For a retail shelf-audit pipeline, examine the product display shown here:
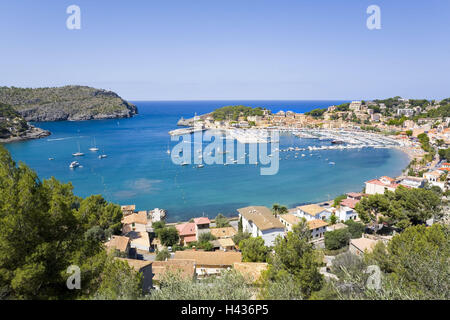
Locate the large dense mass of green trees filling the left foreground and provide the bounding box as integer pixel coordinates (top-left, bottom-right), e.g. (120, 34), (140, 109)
(0, 146), (122, 299)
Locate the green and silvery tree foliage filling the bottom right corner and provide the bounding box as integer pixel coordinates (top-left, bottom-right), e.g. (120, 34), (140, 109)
(326, 225), (450, 300)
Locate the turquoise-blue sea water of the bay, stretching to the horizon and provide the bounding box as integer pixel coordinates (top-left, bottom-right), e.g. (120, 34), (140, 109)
(6, 101), (408, 221)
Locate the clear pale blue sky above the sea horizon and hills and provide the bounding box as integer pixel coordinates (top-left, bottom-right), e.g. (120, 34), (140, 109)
(0, 0), (450, 100)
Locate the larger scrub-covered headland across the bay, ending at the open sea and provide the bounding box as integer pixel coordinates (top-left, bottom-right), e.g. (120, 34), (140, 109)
(0, 86), (137, 121)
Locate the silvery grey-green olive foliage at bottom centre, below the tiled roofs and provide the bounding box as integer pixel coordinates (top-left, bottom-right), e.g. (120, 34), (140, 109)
(146, 270), (253, 300)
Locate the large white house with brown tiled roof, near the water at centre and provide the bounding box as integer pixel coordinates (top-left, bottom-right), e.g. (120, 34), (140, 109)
(237, 206), (284, 247)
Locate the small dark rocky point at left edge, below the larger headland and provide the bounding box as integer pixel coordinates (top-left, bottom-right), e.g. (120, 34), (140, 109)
(0, 103), (50, 143)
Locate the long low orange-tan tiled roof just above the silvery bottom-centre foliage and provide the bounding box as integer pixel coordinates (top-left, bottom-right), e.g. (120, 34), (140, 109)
(174, 250), (242, 267)
